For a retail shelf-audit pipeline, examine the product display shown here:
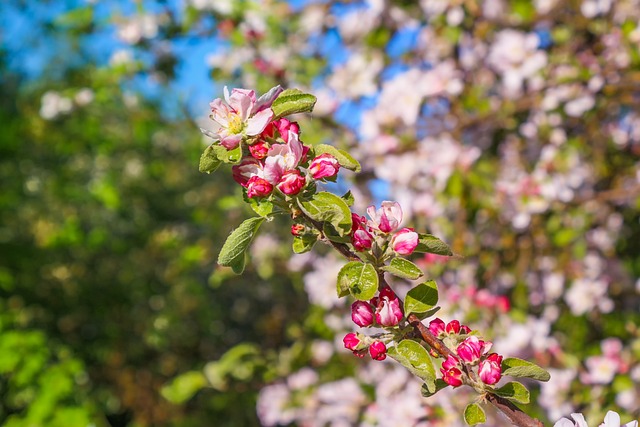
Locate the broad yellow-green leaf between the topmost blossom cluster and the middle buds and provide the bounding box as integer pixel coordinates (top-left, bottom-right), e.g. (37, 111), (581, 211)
(298, 191), (351, 236)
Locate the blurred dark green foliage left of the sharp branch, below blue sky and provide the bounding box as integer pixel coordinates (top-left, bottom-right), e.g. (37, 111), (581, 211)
(0, 42), (306, 426)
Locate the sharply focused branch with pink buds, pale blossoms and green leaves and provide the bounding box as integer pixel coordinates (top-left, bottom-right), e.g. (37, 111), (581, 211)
(200, 86), (549, 427)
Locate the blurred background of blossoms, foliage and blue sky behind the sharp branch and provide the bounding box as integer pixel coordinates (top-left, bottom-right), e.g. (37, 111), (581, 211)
(0, 0), (640, 427)
